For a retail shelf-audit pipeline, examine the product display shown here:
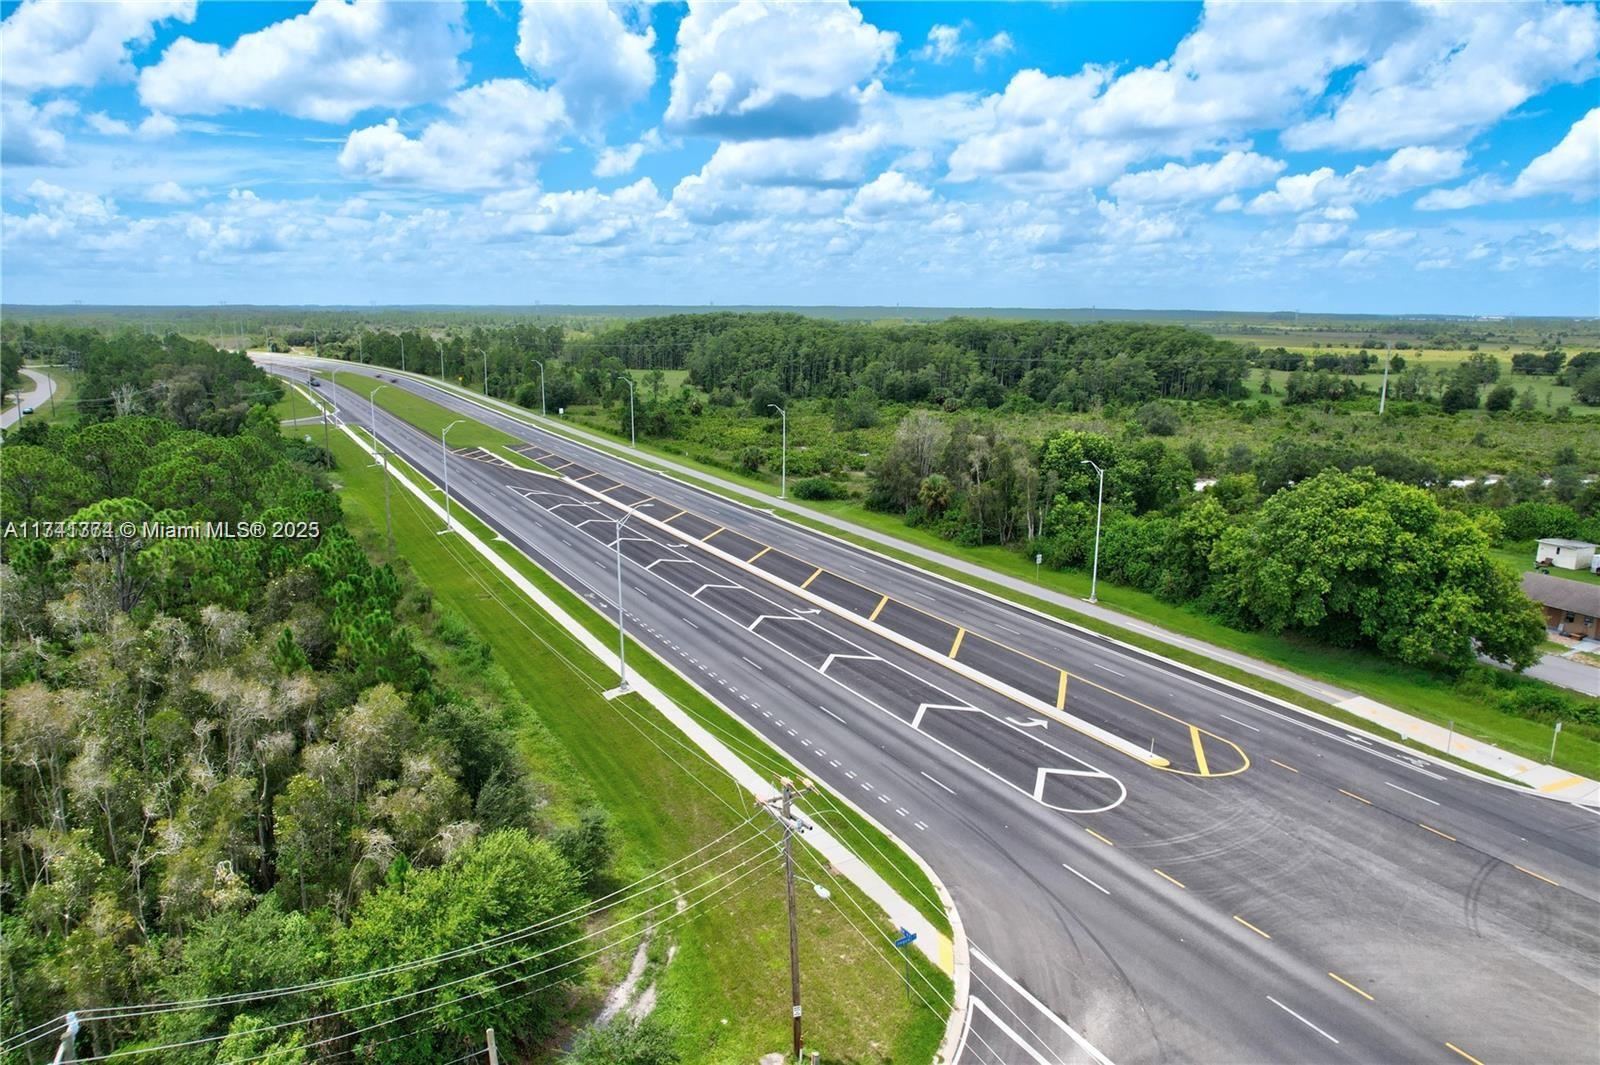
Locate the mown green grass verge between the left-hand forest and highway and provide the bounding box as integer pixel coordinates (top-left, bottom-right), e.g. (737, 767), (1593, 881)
(321, 422), (950, 1062)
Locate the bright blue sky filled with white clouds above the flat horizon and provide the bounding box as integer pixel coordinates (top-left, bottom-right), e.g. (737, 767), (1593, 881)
(0, 0), (1600, 315)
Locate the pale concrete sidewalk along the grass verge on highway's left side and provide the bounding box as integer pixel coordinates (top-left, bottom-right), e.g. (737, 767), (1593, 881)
(302, 385), (970, 1060)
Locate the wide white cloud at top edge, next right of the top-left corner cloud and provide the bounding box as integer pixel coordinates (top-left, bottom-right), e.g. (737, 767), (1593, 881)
(139, 0), (467, 122)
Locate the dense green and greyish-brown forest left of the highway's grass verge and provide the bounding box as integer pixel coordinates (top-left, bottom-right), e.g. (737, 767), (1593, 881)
(0, 342), (610, 1065)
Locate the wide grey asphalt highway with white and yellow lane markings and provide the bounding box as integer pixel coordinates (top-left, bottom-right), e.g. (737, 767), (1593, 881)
(272, 357), (1600, 1065)
